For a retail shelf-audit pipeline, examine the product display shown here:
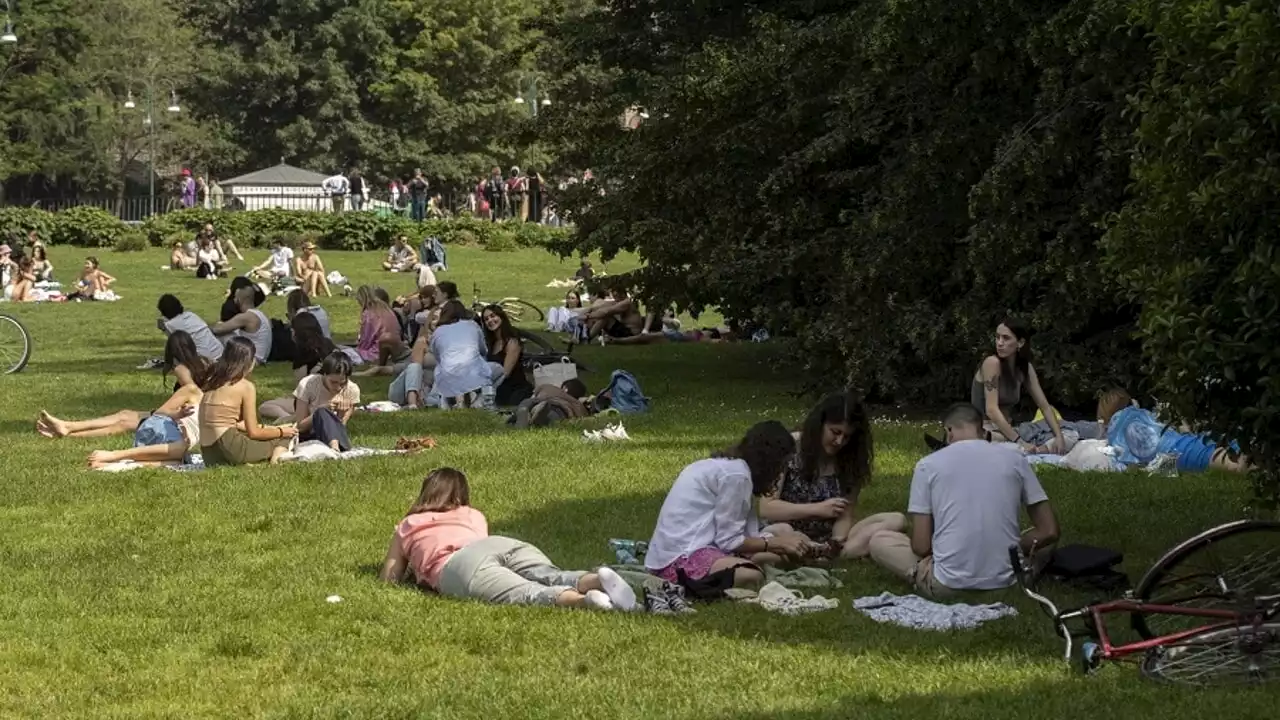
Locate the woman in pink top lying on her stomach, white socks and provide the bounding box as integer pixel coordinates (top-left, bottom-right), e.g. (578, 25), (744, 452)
(379, 468), (636, 610)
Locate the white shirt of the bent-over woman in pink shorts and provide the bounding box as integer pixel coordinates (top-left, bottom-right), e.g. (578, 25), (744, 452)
(644, 457), (760, 570)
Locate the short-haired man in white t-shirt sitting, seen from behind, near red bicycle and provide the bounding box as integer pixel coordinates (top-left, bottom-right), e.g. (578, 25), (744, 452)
(870, 404), (1057, 597)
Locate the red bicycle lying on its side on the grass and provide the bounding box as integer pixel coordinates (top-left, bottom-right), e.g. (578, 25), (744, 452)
(1009, 520), (1280, 685)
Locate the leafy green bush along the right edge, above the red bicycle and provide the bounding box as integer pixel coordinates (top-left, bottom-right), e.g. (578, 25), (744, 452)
(1105, 0), (1280, 506)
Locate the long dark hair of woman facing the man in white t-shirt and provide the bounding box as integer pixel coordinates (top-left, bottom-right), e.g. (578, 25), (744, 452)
(797, 392), (873, 495)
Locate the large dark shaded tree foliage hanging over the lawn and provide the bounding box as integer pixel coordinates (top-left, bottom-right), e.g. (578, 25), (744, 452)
(545, 0), (1149, 404)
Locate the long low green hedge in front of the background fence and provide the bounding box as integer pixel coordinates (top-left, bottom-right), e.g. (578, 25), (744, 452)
(0, 206), (567, 251)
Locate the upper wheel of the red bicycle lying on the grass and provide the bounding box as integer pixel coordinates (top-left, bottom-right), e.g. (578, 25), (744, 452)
(1132, 520), (1280, 638)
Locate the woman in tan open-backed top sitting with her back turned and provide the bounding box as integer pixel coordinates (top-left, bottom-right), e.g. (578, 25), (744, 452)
(197, 337), (298, 466)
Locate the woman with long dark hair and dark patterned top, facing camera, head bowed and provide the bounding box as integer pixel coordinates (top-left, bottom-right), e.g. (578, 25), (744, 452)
(760, 393), (906, 557)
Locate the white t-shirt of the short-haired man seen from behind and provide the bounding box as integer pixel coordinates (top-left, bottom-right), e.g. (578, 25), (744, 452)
(906, 439), (1048, 589)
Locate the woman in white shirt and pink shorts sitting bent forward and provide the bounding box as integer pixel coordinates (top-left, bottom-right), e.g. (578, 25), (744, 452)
(645, 420), (812, 587)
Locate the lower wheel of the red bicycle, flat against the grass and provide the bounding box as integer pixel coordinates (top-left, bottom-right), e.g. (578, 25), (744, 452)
(1140, 623), (1280, 687)
